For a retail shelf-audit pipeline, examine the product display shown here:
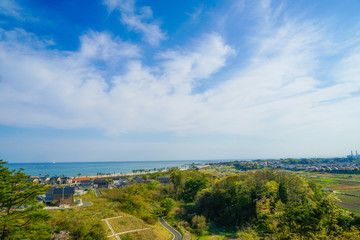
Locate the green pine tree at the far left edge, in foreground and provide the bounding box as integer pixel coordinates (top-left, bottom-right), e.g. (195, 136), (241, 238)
(0, 159), (51, 240)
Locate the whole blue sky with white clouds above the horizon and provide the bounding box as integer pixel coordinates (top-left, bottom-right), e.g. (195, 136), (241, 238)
(0, 0), (360, 163)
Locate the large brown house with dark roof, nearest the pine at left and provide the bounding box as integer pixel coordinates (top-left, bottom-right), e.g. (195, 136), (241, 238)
(45, 187), (75, 206)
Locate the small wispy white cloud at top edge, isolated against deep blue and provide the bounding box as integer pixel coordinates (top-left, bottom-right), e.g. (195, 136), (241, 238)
(104, 0), (166, 46)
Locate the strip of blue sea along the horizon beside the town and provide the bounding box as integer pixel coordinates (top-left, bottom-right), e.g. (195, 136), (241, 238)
(6, 160), (231, 177)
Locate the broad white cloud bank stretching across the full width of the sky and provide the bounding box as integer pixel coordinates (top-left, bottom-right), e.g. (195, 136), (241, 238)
(0, 1), (360, 159)
